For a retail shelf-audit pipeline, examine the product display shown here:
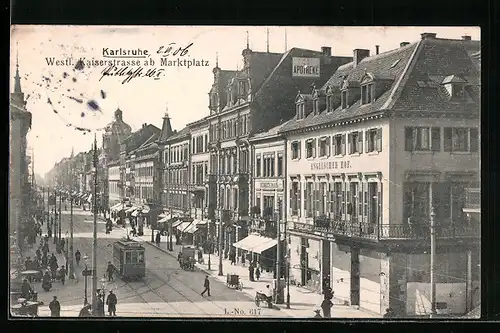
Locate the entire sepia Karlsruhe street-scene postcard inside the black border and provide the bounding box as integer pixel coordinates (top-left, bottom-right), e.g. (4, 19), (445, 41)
(9, 25), (481, 320)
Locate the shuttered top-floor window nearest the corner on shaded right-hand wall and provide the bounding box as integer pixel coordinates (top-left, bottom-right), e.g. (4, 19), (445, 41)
(405, 127), (441, 151)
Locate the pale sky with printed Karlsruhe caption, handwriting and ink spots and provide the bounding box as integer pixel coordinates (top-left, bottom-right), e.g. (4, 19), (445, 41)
(10, 25), (480, 176)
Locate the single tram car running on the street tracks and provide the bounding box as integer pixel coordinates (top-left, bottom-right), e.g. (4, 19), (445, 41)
(113, 239), (146, 280)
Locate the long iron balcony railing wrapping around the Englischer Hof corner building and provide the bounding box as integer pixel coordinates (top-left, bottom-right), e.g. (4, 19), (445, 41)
(292, 218), (480, 241)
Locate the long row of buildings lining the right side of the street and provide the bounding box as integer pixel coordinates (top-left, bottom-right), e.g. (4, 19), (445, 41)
(49, 33), (481, 316)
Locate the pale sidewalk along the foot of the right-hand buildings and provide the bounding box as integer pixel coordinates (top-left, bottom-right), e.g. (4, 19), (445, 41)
(136, 228), (380, 318)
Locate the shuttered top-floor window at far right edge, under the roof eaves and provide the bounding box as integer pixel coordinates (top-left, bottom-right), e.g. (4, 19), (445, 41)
(443, 127), (479, 152)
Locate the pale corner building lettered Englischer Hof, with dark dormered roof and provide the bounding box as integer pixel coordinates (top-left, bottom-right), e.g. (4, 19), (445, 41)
(281, 33), (480, 317)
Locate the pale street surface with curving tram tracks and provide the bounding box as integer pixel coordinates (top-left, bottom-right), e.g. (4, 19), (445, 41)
(28, 200), (377, 318)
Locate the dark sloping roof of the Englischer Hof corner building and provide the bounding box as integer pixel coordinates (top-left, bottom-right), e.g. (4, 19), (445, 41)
(281, 38), (480, 132)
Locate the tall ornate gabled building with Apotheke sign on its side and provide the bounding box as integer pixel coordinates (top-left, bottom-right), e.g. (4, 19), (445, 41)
(207, 42), (349, 255)
